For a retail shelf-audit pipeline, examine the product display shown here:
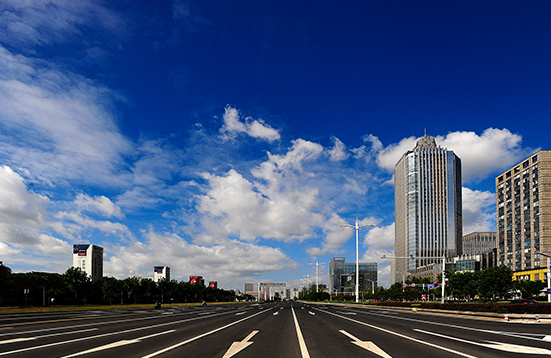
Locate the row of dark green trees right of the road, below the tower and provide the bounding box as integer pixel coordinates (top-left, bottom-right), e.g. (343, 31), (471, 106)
(299, 266), (547, 301)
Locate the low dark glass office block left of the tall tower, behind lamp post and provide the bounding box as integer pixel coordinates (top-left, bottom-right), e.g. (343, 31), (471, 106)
(329, 257), (379, 295)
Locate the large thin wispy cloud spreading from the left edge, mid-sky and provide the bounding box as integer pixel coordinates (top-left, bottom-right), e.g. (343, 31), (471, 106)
(0, 47), (132, 185)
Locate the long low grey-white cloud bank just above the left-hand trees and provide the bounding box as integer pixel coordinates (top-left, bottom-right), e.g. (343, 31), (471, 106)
(105, 230), (297, 287)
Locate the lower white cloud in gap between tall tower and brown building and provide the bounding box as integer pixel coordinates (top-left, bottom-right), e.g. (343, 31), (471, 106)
(463, 187), (496, 235)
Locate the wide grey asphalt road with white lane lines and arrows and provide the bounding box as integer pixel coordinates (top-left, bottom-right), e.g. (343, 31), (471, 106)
(0, 302), (551, 358)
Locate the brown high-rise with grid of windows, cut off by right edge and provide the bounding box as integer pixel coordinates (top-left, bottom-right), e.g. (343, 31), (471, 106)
(496, 150), (551, 274)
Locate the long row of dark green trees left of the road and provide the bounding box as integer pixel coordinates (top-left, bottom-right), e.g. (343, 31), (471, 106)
(0, 267), (246, 306)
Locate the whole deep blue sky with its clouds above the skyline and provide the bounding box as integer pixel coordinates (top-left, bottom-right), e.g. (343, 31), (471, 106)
(0, 0), (551, 289)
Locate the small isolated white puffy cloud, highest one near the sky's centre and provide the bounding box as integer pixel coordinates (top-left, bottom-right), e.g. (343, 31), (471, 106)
(220, 106), (280, 142)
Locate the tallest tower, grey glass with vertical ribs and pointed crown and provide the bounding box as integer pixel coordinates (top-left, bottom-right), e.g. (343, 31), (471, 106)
(393, 134), (463, 281)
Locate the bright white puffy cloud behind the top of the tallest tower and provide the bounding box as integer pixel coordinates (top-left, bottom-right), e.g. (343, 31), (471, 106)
(377, 128), (535, 182)
